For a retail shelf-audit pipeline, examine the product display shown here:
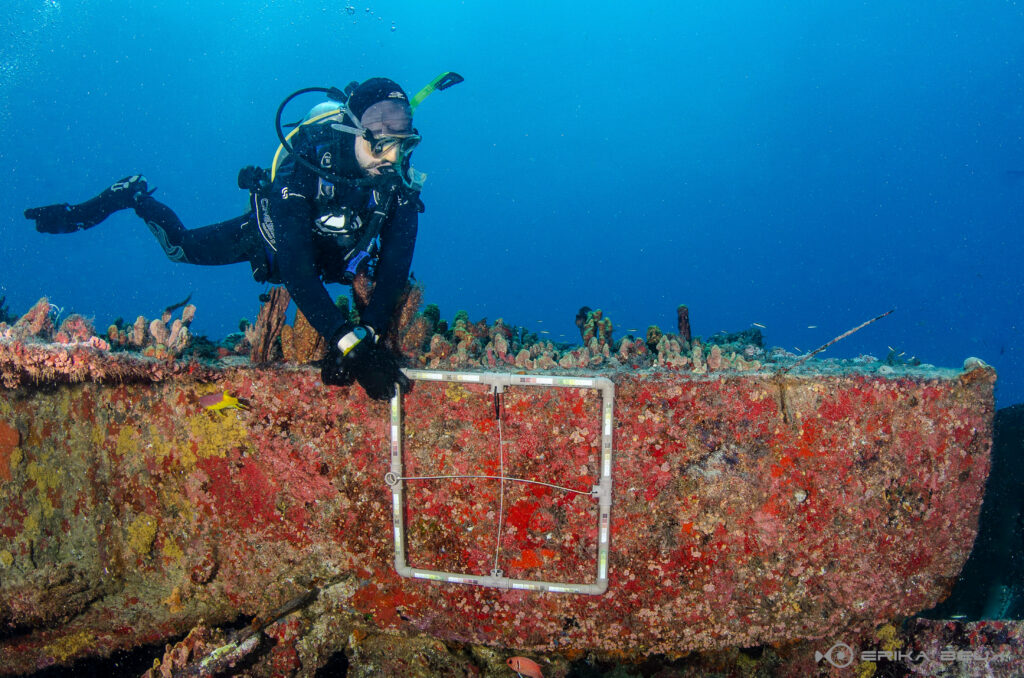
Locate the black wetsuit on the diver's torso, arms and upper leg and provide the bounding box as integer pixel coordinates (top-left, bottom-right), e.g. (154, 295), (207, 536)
(134, 120), (423, 338)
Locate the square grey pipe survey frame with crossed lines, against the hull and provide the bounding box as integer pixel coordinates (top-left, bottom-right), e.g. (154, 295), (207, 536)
(385, 370), (614, 595)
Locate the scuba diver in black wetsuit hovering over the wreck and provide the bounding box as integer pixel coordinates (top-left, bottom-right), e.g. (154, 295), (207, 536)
(25, 73), (462, 399)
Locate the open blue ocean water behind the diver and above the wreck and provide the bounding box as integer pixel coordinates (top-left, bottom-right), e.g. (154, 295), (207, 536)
(0, 0), (1024, 405)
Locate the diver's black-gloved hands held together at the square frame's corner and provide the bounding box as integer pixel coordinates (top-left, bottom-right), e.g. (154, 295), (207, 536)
(321, 325), (412, 400)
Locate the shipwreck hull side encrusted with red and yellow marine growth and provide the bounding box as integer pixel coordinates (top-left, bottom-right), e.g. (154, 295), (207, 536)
(0, 349), (994, 672)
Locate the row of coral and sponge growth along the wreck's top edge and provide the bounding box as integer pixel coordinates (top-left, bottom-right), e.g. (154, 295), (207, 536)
(0, 288), (864, 383)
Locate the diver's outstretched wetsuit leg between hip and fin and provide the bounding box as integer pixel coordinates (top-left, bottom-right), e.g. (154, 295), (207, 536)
(135, 196), (260, 266)
